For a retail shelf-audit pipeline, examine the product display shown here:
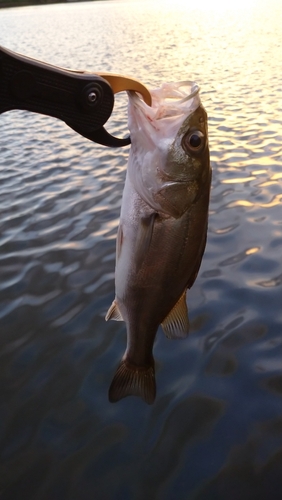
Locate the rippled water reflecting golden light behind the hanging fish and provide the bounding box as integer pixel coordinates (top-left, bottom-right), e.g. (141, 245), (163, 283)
(0, 0), (282, 500)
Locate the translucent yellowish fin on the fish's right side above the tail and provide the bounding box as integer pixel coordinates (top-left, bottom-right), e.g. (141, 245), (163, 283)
(162, 290), (189, 339)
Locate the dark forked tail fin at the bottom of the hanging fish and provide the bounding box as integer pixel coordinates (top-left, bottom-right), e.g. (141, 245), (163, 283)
(109, 359), (156, 405)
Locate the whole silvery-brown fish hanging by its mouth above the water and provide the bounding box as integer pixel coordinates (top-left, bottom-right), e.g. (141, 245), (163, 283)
(105, 82), (211, 404)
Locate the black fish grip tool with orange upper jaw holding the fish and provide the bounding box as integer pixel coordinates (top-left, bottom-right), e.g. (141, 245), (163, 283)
(0, 47), (151, 147)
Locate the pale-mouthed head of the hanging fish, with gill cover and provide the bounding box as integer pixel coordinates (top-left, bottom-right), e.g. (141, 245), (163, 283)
(128, 82), (210, 218)
